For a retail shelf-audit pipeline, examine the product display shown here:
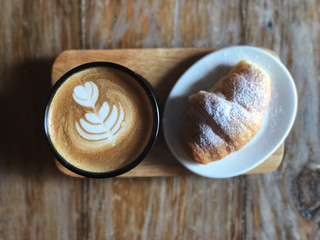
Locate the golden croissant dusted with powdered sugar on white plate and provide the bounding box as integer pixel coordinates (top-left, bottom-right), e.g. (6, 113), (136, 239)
(180, 60), (271, 164)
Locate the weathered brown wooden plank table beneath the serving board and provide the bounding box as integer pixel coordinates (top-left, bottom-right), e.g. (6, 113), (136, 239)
(0, 0), (320, 240)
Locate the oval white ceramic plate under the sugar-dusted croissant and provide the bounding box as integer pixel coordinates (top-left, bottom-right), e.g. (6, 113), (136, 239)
(163, 46), (297, 178)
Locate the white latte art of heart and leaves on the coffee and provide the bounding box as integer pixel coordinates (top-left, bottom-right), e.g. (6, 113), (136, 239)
(73, 81), (124, 141)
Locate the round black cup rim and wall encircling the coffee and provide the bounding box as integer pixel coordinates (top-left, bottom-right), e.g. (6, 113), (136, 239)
(44, 62), (160, 178)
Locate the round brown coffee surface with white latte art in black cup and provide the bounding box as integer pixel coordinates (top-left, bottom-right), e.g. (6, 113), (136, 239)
(48, 67), (153, 173)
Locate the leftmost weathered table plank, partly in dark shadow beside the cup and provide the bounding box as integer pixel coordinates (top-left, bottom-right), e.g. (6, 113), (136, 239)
(0, 1), (84, 240)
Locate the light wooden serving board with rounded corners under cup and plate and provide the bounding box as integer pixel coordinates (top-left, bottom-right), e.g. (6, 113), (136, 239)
(52, 48), (284, 177)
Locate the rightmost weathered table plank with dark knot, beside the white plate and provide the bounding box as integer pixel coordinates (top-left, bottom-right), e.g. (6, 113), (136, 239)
(245, 1), (320, 239)
